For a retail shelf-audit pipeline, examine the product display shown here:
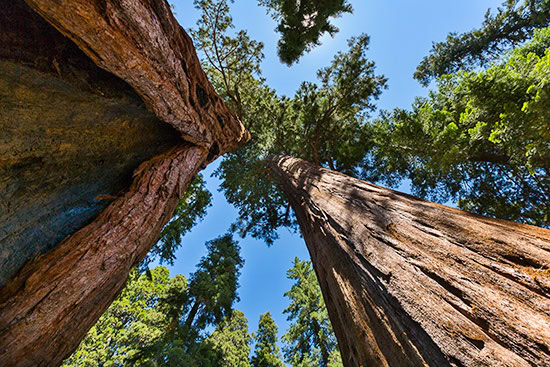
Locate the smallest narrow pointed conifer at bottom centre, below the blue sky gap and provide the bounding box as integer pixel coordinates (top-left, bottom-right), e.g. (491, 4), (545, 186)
(251, 312), (284, 367)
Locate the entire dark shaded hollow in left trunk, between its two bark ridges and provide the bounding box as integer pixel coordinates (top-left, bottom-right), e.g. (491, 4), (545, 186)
(0, 0), (181, 288)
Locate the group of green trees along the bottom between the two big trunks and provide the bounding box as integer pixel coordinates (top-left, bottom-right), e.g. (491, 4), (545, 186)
(64, 260), (342, 367)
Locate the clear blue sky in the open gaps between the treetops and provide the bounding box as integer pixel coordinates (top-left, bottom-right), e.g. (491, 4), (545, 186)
(164, 0), (502, 354)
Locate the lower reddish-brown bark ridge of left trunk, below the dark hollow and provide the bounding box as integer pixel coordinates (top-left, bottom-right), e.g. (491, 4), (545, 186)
(0, 145), (207, 366)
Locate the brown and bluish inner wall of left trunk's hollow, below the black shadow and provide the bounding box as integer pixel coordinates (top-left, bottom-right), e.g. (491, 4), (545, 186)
(0, 60), (179, 288)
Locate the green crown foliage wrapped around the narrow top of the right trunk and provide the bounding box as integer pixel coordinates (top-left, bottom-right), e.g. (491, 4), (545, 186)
(215, 35), (386, 244)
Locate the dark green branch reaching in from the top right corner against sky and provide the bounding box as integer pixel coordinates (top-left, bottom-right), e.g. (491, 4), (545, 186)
(414, 0), (550, 86)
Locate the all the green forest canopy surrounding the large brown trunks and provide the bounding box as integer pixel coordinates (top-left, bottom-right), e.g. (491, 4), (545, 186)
(66, 0), (550, 366)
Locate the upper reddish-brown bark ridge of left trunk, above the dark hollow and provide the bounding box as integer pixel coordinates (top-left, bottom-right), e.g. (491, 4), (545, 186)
(26, 0), (250, 154)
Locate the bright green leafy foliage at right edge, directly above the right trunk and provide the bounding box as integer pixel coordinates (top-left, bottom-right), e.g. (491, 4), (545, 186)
(374, 28), (550, 226)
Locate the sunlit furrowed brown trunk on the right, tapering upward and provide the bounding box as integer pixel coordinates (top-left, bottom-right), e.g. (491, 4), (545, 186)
(271, 157), (550, 367)
